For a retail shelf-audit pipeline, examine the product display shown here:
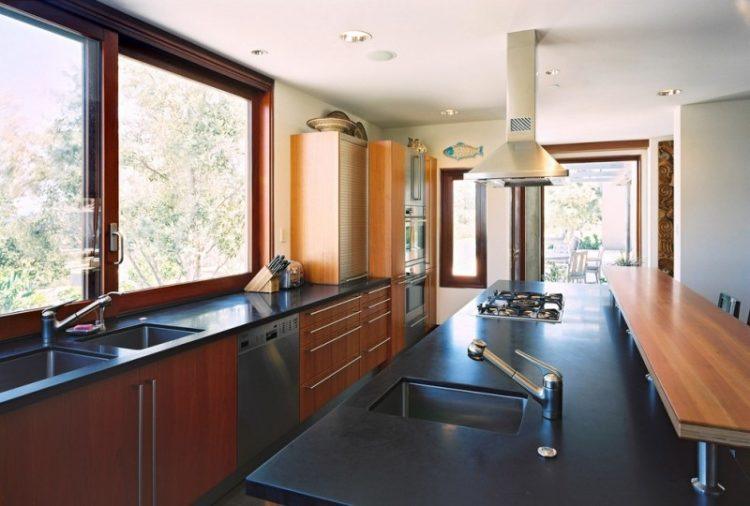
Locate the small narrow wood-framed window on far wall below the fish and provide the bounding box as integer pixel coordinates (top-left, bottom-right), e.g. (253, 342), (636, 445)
(440, 169), (487, 288)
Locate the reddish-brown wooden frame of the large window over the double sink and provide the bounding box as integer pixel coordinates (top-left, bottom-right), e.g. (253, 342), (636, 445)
(0, 0), (274, 339)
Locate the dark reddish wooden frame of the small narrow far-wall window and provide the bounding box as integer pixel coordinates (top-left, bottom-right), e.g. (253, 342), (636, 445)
(440, 168), (487, 288)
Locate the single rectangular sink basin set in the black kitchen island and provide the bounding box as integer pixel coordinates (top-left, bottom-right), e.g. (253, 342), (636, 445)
(370, 379), (526, 434)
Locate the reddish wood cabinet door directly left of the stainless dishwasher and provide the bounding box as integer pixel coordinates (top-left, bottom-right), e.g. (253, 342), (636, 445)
(140, 337), (237, 506)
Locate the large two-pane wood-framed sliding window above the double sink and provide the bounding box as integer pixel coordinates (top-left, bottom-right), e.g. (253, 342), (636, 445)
(0, 0), (273, 339)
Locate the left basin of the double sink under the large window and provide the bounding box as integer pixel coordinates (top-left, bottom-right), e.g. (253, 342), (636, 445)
(0, 348), (112, 392)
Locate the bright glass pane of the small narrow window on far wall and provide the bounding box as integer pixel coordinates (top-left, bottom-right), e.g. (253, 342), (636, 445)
(452, 180), (477, 276)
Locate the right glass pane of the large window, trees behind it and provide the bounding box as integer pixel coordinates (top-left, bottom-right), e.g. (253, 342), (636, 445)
(119, 56), (249, 290)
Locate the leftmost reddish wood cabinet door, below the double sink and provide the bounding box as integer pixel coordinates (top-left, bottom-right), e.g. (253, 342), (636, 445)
(0, 370), (138, 505)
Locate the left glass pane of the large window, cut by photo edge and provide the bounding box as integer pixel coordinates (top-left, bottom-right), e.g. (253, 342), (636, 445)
(0, 9), (99, 313)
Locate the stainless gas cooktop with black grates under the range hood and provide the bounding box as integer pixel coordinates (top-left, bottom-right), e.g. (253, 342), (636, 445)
(477, 290), (563, 323)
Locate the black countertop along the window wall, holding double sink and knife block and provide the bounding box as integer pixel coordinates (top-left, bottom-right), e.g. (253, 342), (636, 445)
(0, 278), (389, 411)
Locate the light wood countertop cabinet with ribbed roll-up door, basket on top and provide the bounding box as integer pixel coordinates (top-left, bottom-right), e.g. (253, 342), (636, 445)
(291, 132), (368, 284)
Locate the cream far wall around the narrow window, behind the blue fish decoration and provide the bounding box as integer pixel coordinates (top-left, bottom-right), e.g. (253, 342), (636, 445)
(385, 120), (511, 323)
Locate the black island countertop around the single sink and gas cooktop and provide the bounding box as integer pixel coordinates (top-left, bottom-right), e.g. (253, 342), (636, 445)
(246, 281), (750, 506)
